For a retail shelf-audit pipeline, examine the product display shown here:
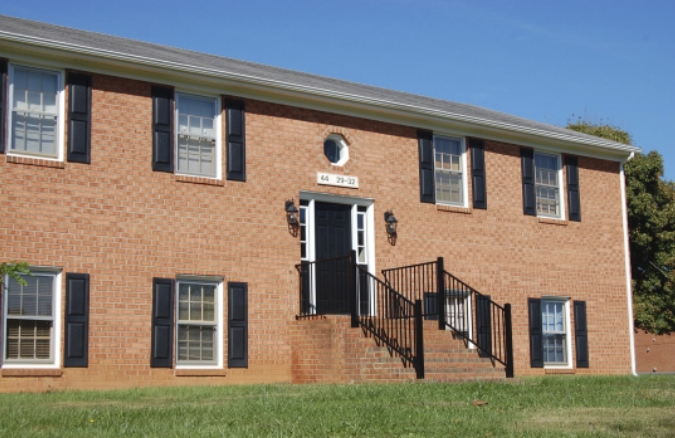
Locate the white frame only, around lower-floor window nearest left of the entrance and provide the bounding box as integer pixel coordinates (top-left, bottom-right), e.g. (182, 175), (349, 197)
(173, 275), (225, 370)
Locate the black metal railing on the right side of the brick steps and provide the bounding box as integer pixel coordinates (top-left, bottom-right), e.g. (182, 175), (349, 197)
(382, 257), (513, 377)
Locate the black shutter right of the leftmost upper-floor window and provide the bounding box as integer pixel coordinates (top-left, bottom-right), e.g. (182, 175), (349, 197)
(68, 72), (91, 164)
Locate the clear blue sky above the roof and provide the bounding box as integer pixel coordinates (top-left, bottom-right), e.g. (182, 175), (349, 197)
(0, 0), (675, 180)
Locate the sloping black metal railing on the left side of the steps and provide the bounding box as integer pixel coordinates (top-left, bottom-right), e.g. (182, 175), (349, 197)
(357, 266), (424, 379)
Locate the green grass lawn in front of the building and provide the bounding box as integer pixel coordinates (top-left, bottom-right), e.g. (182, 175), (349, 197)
(0, 375), (675, 437)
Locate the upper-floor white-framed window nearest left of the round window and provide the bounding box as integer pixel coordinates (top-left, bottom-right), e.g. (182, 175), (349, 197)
(176, 93), (221, 178)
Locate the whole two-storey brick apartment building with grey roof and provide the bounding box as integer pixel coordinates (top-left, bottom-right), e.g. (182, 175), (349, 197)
(0, 16), (638, 391)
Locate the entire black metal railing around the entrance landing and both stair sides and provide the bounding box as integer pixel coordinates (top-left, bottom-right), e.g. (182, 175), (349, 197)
(296, 251), (513, 378)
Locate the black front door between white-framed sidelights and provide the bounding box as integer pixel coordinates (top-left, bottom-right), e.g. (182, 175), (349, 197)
(314, 202), (352, 314)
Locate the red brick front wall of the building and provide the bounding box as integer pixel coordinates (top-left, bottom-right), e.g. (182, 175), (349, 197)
(0, 70), (630, 391)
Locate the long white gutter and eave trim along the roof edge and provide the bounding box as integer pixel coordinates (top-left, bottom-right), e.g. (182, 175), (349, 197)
(0, 30), (640, 154)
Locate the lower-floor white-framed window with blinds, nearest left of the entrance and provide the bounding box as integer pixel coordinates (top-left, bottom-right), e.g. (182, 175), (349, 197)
(176, 278), (223, 368)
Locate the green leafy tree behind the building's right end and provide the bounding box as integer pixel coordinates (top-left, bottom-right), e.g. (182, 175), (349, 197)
(567, 120), (675, 334)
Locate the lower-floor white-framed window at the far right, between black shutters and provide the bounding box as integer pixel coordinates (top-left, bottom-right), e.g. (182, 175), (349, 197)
(541, 297), (572, 368)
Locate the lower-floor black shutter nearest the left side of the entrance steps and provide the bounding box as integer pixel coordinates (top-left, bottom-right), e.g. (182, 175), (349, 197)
(227, 282), (248, 368)
